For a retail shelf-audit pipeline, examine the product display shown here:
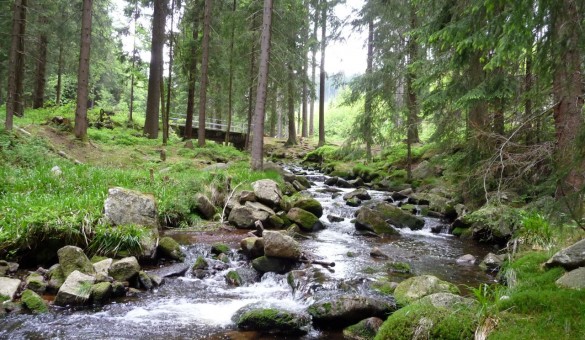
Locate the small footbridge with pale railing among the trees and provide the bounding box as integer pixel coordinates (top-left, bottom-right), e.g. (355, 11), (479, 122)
(171, 117), (248, 150)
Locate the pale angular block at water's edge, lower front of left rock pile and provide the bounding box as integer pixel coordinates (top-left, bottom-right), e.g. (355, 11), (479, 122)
(54, 270), (95, 306)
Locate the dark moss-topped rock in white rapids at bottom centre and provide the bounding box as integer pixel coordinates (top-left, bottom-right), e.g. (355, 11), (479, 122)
(236, 307), (311, 335)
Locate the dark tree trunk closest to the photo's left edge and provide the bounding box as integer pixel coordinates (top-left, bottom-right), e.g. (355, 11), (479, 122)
(5, 0), (22, 131)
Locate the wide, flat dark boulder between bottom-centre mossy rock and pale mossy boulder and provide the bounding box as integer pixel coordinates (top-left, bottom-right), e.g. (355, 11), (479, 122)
(308, 295), (396, 327)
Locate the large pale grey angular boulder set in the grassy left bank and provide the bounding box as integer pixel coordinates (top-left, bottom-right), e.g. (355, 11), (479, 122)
(104, 187), (158, 232)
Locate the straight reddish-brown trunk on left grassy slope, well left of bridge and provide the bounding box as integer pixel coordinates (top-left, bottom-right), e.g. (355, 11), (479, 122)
(74, 0), (93, 140)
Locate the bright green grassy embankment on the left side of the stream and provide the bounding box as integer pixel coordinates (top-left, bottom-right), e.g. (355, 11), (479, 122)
(0, 106), (279, 259)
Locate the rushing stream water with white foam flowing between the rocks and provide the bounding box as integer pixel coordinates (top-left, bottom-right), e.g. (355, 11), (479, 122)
(0, 169), (493, 339)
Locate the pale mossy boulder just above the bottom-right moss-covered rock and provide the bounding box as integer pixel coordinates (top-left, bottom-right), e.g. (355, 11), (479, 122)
(394, 275), (460, 305)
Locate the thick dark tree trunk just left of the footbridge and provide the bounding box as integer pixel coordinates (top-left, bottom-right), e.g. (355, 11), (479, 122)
(144, 0), (167, 139)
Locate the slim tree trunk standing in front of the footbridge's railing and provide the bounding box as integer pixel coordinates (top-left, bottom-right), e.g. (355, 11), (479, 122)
(197, 0), (212, 147)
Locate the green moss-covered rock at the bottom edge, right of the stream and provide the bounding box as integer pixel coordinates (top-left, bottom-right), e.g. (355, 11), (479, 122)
(375, 301), (477, 340)
